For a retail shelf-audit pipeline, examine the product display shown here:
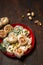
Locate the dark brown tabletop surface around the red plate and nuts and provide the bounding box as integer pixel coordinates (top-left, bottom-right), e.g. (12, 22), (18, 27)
(0, 0), (43, 65)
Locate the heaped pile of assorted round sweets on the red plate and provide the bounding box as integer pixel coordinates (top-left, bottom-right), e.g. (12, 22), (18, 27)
(2, 24), (32, 58)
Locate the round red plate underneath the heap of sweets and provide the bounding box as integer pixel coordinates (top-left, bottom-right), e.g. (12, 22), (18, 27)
(0, 24), (35, 57)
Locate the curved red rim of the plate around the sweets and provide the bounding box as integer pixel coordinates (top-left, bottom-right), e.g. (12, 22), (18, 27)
(1, 23), (35, 58)
